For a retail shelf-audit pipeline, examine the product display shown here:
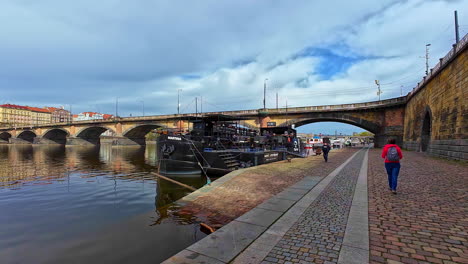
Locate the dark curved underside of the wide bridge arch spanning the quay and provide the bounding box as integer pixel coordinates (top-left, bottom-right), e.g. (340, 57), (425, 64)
(279, 115), (381, 134)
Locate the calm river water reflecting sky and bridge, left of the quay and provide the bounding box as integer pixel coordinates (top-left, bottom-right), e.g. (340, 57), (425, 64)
(0, 145), (206, 264)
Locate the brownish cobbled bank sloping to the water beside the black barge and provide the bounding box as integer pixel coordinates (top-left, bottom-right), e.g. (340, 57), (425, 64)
(177, 148), (358, 228)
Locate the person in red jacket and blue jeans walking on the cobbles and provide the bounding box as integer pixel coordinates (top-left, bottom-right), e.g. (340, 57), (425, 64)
(382, 138), (403, 194)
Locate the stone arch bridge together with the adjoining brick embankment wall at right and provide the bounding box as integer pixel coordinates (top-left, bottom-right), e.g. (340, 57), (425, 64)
(0, 34), (468, 161)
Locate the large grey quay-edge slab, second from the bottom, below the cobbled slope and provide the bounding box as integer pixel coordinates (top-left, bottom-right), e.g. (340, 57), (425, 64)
(187, 220), (266, 262)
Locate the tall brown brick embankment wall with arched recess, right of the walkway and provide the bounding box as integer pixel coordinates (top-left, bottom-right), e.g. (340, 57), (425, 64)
(403, 41), (468, 160)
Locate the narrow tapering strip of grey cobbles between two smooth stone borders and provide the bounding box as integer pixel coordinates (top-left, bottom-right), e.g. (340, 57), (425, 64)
(262, 151), (365, 263)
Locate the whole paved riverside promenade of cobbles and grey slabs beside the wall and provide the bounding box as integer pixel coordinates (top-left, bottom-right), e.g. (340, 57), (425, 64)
(164, 148), (468, 264)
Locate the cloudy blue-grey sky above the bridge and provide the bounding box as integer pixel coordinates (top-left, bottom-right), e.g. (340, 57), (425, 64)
(0, 0), (468, 132)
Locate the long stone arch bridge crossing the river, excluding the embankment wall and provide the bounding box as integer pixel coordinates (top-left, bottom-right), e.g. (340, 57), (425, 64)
(0, 97), (406, 145)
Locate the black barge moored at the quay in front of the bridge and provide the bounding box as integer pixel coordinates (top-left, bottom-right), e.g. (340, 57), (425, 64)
(157, 115), (302, 176)
